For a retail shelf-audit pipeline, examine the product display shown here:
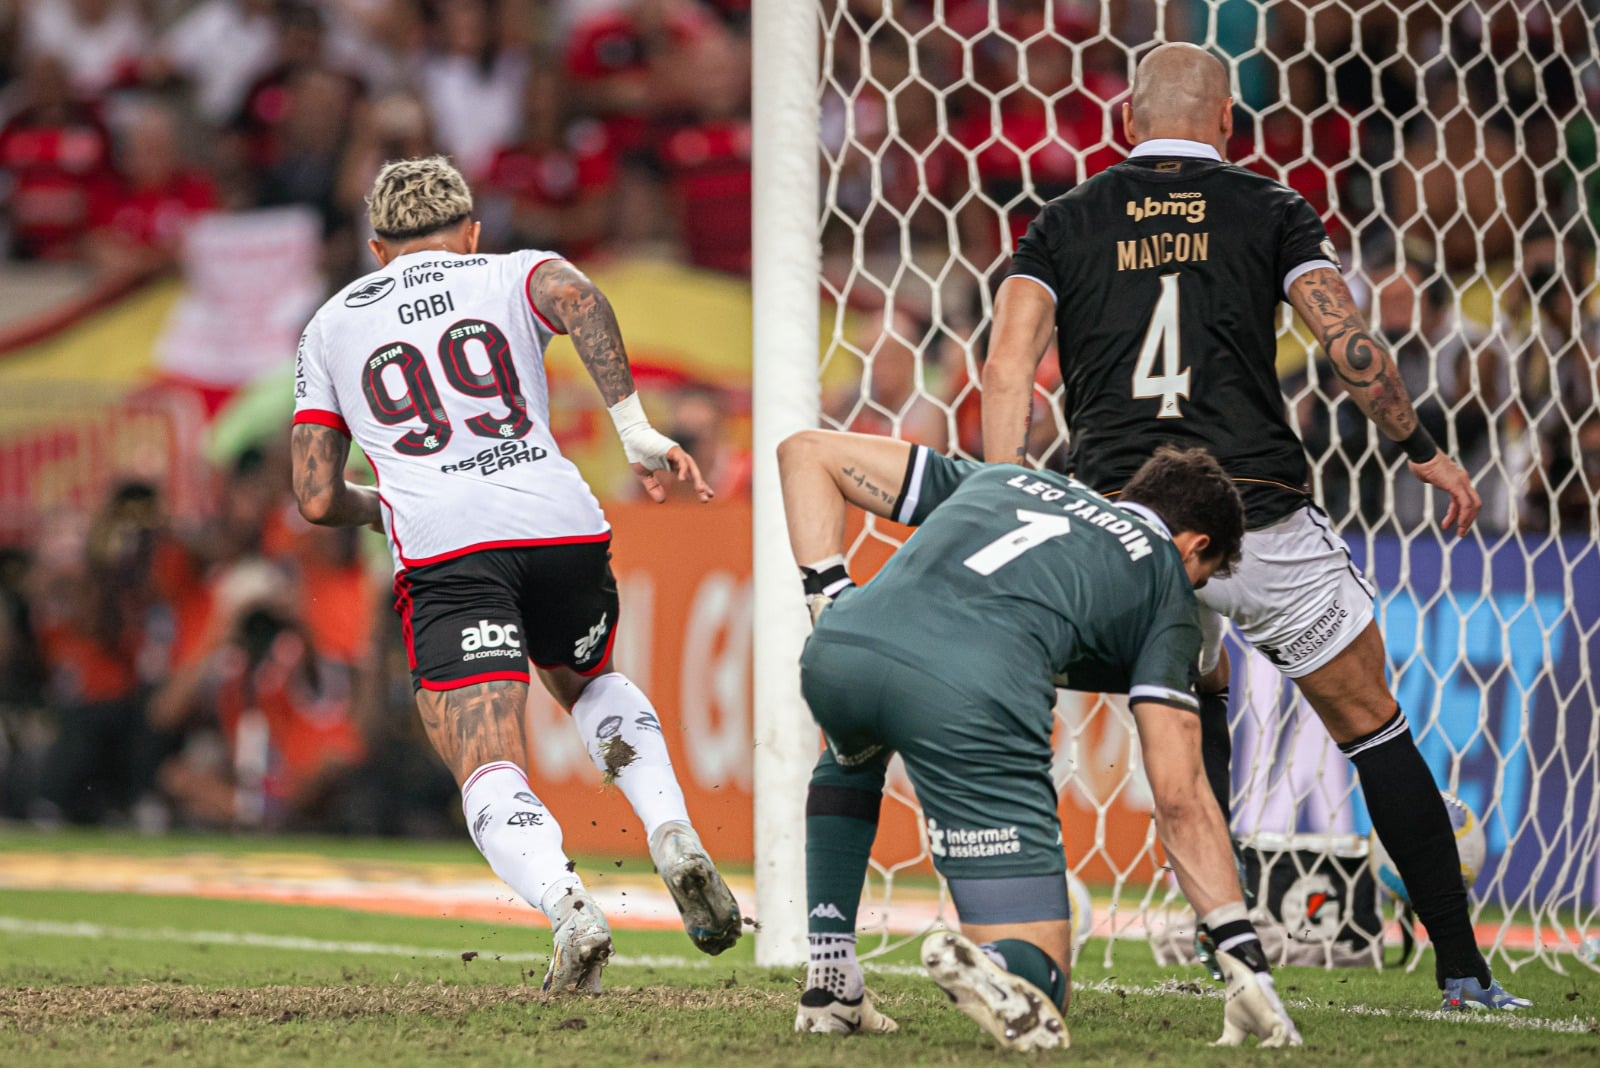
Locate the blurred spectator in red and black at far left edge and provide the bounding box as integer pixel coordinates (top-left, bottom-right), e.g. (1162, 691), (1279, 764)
(0, 53), (112, 259)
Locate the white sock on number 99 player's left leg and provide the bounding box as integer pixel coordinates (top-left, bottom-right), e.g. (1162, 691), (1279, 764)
(461, 761), (584, 923)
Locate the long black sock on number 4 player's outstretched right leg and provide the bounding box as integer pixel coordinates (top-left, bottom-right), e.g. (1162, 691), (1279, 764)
(1339, 710), (1490, 986)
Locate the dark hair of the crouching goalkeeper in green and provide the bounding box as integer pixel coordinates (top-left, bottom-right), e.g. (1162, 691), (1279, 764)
(1120, 444), (1245, 576)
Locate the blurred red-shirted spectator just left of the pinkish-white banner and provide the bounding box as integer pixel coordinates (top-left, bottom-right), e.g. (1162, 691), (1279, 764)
(88, 102), (218, 277)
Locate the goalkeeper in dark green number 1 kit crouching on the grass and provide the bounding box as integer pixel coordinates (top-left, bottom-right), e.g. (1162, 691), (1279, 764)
(778, 430), (1299, 1049)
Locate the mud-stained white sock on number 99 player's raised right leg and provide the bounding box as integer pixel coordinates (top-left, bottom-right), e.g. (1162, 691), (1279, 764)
(573, 671), (690, 841)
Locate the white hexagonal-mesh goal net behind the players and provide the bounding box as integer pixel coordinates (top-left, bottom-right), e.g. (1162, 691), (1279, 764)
(757, 0), (1600, 967)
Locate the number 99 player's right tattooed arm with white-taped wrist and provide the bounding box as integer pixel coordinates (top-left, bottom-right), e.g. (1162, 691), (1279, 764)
(528, 259), (715, 502)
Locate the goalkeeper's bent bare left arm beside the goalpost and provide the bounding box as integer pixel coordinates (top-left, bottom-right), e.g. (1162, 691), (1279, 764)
(778, 430), (912, 566)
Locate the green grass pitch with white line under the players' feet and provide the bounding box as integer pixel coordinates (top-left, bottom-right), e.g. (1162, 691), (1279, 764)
(0, 839), (1600, 1068)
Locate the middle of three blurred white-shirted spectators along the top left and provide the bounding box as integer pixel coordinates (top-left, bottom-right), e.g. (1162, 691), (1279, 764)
(142, 0), (278, 126)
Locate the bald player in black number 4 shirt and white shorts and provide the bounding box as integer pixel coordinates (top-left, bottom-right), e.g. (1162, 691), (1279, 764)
(982, 45), (1528, 1009)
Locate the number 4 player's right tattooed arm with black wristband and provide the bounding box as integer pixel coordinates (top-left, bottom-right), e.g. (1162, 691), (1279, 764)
(1290, 267), (1483, 534)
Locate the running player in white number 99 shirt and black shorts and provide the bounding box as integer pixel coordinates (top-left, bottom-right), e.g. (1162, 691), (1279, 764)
(291, 157), (741, 991)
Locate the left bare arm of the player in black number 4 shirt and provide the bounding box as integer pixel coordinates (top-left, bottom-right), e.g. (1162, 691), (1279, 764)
(982, 278), (1056, 464)
